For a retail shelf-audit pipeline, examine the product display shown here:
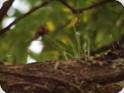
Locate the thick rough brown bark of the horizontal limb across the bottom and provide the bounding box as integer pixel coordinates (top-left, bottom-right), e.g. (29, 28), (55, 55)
(0, 50), (124, 93)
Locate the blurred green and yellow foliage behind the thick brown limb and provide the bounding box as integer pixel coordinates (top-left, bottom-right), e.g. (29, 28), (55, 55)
(0, 0), (124, 64)
